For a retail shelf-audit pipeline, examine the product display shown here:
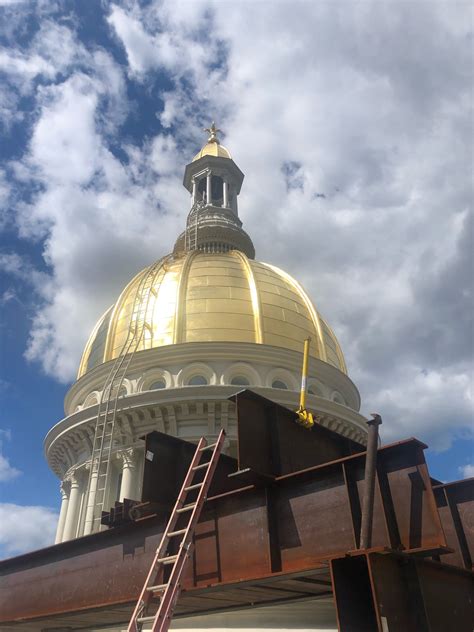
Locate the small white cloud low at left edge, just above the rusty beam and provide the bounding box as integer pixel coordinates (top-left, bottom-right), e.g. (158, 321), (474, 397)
(0, 503), (58, 557)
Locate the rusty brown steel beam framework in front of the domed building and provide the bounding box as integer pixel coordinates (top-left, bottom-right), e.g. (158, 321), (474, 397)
(0, 391), (474, 632)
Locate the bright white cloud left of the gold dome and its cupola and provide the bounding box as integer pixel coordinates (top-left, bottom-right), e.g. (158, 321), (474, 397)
(10, 64), (183, 381)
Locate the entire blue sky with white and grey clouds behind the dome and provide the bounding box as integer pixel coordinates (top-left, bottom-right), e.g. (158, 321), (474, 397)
(0, 0), (474, 556)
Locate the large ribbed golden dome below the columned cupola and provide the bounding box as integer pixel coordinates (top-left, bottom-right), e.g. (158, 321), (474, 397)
(78, 250), (346, 378)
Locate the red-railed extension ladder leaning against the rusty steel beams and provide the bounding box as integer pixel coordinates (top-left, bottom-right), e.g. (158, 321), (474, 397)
(127, 430), (225, 632)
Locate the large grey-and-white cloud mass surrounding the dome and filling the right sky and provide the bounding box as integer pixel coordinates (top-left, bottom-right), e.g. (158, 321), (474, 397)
(3, 1), (473, 449)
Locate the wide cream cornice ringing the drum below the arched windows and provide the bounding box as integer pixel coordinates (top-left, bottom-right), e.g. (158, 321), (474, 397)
(44, 385), (366, 476)
